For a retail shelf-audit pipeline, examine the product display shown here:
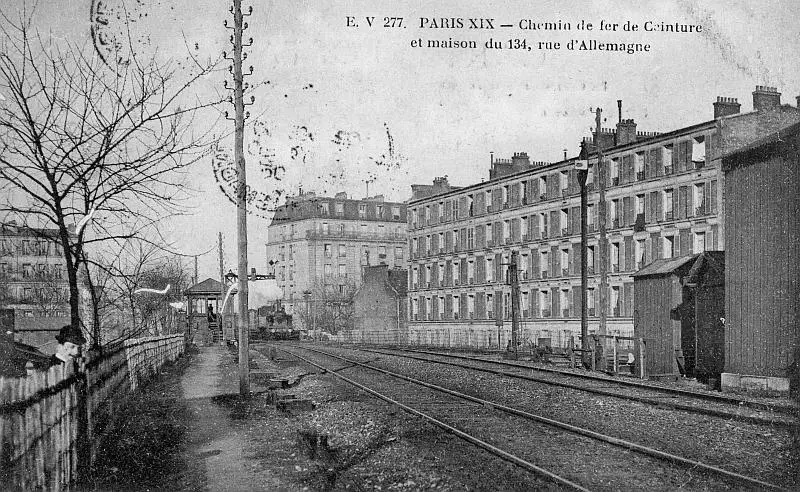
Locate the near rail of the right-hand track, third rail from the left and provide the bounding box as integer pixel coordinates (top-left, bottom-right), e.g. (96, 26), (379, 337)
(354, 348), (797, 427)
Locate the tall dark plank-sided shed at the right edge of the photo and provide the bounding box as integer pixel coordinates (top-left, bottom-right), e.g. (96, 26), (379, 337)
(722, 119), (800, 392)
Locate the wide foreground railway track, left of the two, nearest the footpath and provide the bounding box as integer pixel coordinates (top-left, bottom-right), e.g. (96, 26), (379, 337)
(272, 346), (781, 490)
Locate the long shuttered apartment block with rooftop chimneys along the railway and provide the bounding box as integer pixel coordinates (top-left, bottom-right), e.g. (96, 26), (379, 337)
(408, 86), (799, 346)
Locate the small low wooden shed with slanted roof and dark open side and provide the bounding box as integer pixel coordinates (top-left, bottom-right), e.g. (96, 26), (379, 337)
(633, 251), (725, 380)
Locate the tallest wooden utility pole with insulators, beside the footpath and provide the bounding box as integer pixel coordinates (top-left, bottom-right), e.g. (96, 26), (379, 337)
(223, 0), (254, 395)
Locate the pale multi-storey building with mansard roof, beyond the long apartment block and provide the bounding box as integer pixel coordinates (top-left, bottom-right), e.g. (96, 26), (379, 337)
(266, 193), (408, 329)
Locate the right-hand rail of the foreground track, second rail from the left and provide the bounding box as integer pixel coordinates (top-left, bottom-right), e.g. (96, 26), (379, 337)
(290, 347), (786, 490)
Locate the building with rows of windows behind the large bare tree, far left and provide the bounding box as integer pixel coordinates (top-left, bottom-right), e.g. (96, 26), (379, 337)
(0, 222), (70, 352)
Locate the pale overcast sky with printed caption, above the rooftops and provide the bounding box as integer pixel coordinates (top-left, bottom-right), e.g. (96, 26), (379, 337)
(17, 0), (800, 279)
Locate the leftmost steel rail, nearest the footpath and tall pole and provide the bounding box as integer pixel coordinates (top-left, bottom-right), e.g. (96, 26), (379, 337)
(278, 347), (589, 492)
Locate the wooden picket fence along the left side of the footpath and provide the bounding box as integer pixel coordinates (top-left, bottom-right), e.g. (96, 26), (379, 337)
(0, 334), (186, 491)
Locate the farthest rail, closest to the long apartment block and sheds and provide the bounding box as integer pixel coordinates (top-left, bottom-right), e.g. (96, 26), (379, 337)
(384, 348), (800, 415)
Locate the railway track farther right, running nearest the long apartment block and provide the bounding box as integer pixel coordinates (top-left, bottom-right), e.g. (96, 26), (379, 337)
(359, 348), (798, 427)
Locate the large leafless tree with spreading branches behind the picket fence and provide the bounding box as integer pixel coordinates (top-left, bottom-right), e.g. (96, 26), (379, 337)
(0, 6), (219, 334)
